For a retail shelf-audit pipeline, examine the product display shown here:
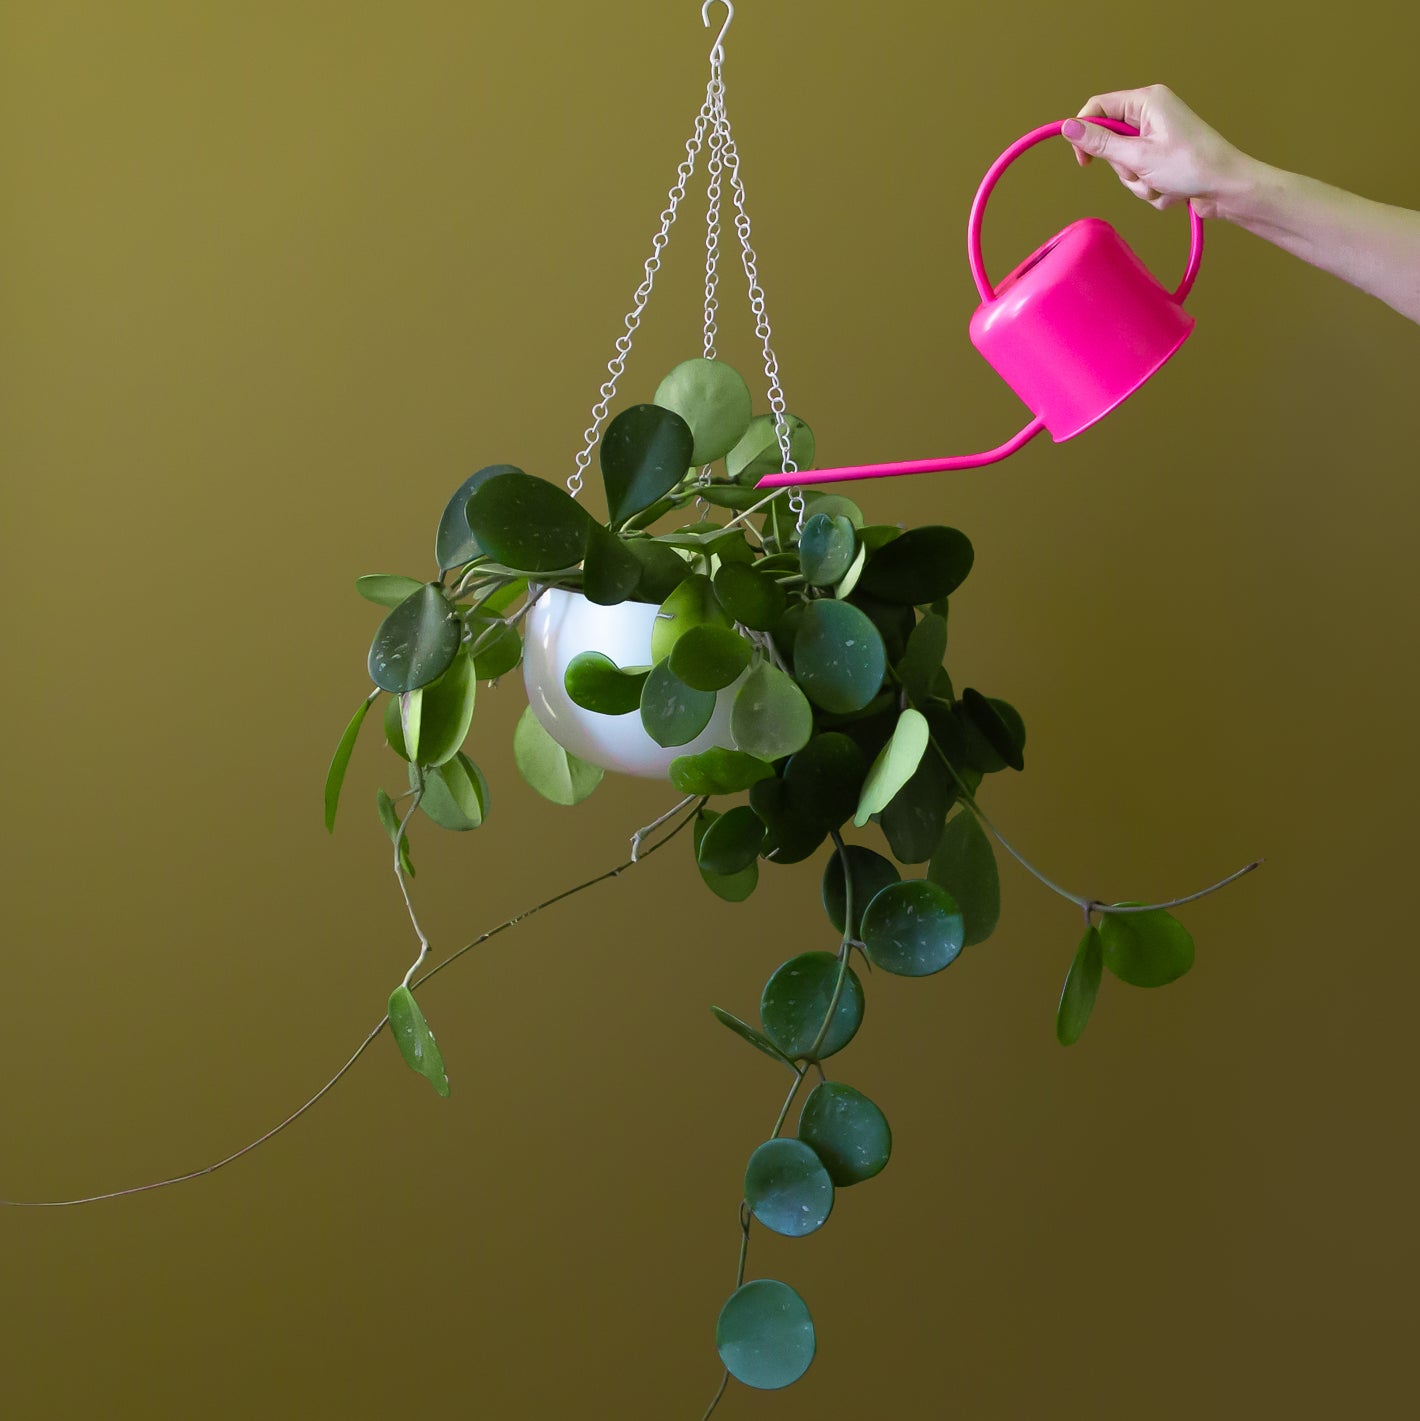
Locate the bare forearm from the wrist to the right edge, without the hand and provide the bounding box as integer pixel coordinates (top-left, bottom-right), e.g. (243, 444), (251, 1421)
(1218, 159), (1420, 321)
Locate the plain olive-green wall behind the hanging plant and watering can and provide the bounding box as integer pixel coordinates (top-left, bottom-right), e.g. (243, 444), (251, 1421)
(0, 0), (1420, 1421)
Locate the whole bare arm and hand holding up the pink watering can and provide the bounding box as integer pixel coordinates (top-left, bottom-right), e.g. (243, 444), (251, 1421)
(1065, 84), (1420, 323)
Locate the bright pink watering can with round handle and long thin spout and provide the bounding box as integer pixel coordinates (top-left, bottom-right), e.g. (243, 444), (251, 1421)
(756, 118), (1203, 489)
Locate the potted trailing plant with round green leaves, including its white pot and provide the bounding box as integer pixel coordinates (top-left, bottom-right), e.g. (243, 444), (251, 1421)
(326, 349), (1251, 1407)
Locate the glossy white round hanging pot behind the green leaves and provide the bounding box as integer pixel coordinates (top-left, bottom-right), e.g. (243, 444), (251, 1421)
(523, 587), (739, 779)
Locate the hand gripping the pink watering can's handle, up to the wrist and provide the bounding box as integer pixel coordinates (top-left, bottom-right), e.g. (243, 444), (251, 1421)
(1063, 84), (1251, 217)
